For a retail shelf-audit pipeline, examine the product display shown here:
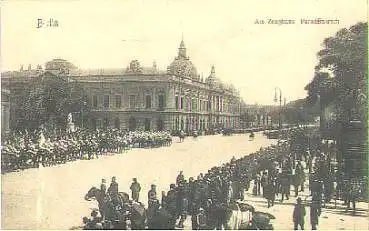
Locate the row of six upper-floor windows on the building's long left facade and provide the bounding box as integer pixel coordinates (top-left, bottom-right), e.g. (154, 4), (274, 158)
(92, 95), (165, 109)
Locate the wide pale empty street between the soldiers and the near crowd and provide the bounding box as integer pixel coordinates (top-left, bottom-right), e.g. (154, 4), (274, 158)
(1, 133), (276, 229)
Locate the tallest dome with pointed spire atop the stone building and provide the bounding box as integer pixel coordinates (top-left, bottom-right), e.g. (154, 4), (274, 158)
(167, 40), (199, 80)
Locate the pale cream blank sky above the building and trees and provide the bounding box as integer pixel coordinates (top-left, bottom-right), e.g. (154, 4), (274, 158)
(1, 0), (367, 104)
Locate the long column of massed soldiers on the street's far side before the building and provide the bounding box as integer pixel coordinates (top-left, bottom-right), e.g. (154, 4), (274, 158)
(1, 129), (172, 171)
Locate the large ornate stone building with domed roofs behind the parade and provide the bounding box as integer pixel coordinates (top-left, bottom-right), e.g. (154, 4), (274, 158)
(2, 41), (241, 131)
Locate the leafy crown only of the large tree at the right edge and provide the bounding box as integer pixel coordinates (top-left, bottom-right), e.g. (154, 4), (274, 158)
(305, 23), (368, 125)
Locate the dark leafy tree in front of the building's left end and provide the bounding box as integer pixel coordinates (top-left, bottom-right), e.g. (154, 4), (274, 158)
(17, 72), (89, 130)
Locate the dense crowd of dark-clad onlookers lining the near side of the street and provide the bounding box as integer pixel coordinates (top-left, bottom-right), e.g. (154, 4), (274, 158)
(81, 127), (366, 230)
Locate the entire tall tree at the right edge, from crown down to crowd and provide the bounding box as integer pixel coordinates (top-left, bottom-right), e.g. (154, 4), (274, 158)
(305, 23), (368, 179)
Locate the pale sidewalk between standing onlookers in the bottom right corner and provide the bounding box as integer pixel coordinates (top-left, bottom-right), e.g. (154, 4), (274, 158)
(184, 169), (369, 230)
